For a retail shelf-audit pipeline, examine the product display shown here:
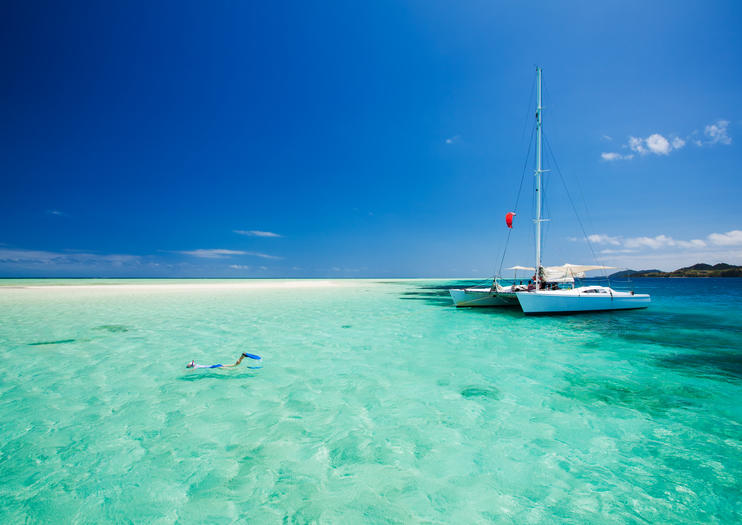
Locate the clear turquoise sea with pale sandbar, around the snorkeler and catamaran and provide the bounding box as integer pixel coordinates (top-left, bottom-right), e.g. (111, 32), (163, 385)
(0, 279), (742, 524)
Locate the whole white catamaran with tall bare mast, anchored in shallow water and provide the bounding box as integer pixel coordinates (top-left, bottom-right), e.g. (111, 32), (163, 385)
(449, 67), (650, 314)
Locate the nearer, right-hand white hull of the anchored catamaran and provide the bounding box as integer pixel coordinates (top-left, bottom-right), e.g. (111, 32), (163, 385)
(515, 291), (650, 314)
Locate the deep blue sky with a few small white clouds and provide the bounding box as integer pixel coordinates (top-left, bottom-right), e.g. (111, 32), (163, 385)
(0, 1), (742, 277)
